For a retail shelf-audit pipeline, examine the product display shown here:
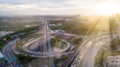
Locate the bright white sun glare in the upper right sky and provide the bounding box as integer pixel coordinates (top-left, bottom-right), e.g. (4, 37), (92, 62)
(93, 2), (120, 15)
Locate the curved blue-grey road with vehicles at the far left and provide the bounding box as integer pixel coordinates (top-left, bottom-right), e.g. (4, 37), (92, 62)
(2, 39), (22, 67)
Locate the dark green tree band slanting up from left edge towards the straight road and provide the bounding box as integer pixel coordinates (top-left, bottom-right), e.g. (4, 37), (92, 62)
(0, 26), (39, 50)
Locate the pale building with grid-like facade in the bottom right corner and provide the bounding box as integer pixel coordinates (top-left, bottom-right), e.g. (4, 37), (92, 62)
(106, 55), (120, 67)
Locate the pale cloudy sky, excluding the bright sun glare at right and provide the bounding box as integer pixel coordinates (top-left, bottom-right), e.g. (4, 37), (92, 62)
(0, 0), (120, 15)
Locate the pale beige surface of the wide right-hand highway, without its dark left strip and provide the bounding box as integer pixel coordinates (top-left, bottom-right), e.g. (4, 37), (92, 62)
(71, 33), (120, 67)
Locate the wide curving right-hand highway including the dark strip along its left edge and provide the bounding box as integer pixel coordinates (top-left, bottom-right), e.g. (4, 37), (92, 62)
(62, 32), (120, 67)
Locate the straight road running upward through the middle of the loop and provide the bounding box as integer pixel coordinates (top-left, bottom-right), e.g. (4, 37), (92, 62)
(42, 21), (55, 67)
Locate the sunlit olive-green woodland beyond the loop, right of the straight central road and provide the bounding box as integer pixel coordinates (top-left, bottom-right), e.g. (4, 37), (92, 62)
(50, 20), (87, 35)
